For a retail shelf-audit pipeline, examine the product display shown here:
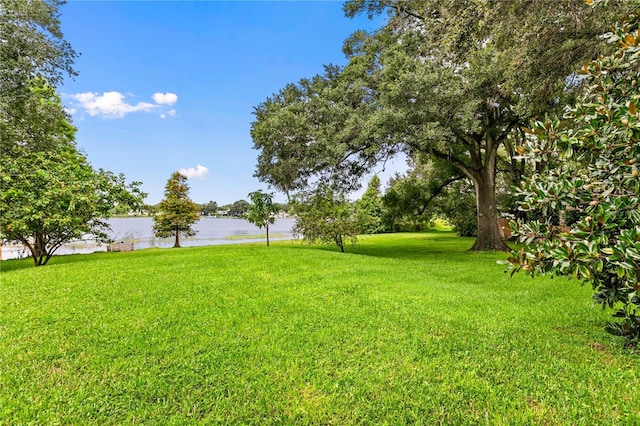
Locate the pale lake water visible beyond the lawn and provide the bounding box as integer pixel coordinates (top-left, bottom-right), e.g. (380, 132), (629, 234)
(2, 217), (295, 259)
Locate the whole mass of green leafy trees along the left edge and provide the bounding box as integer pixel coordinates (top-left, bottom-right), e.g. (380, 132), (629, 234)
(0, 0), (146, 266)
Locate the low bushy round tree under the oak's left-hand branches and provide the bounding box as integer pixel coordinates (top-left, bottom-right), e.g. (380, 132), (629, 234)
(293, 185), (358, 252)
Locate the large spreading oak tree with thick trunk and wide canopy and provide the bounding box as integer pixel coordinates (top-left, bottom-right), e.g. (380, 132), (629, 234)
(252, 0), (624, 250)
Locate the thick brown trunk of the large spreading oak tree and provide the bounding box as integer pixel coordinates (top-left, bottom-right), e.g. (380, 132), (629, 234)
(471, 167), (509, 251)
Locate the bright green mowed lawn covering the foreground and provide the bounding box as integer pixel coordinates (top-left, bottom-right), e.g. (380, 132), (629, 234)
(0, 232), (640, 425)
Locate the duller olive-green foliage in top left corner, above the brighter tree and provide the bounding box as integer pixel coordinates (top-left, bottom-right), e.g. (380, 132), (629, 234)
(0, 0), (77, 155)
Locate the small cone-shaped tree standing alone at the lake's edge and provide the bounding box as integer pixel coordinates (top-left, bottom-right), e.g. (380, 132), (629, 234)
(153, 172), (200, 248)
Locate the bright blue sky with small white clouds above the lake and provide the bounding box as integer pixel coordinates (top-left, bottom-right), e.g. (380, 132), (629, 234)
(59, 0), (404, 205)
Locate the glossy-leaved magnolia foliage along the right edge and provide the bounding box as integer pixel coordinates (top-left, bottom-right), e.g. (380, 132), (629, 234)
(509, 3), (640, 343)
